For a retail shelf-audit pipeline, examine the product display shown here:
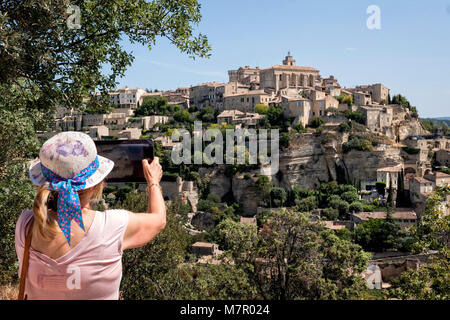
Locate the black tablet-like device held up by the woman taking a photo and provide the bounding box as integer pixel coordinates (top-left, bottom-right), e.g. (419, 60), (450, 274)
(95, 139), (154, 182)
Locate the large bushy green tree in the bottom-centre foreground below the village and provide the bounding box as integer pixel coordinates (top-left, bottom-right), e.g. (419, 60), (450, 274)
(221, 210), (369, 300)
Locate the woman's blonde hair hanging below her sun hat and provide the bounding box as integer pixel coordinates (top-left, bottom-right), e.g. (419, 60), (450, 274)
(33, 181), (103, 241)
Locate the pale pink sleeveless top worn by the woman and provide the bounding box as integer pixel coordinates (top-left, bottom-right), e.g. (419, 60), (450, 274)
(15, 210), (129, 300)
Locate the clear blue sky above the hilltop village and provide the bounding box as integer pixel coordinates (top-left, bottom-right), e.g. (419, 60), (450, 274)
(119, 0), (450, 117)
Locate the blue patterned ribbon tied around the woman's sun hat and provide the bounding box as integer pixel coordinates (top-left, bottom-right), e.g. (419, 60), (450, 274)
(41, 157), (99, 244)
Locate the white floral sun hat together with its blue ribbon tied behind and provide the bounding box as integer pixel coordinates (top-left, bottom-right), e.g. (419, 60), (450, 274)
(30, 131), (114, 244)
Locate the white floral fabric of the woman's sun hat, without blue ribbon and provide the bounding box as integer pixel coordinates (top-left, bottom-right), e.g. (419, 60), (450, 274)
(29, 131), (114, 189)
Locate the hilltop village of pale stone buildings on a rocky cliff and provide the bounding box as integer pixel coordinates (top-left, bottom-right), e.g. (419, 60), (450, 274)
(46, 54), (450, 288)
